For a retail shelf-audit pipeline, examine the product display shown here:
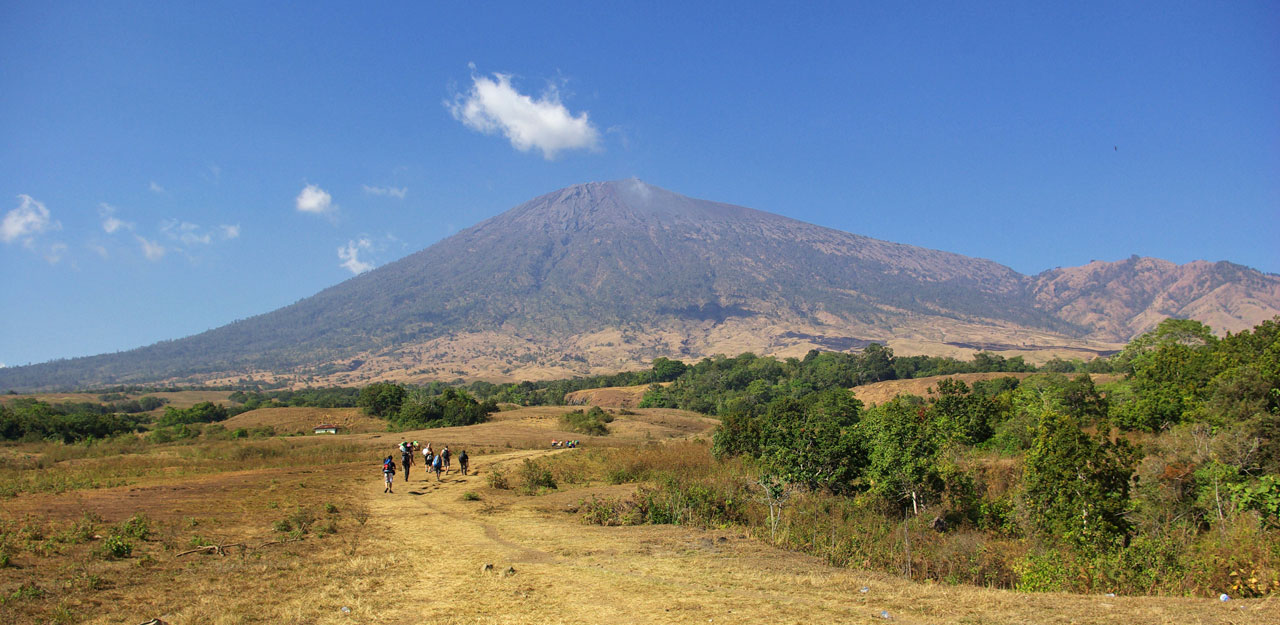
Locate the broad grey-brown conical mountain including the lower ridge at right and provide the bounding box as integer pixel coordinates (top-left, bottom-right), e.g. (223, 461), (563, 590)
(0, 179), (1280, 388)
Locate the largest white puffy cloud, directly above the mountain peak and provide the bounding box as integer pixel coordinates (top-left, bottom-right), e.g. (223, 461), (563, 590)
(444, 73), (600, 160)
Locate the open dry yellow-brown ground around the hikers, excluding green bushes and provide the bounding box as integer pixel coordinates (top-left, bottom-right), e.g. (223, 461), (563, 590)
(0, 409), (1280, 625)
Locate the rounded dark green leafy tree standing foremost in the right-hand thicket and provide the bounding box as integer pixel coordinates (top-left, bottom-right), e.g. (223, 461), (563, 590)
(1023, 412), (1134, 551)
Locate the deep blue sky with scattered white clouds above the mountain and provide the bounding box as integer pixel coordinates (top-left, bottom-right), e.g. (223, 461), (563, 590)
(0, 0), (1280, 366)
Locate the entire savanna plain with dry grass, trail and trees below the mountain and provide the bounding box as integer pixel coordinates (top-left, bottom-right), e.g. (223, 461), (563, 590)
(0, 321), (1280, 624)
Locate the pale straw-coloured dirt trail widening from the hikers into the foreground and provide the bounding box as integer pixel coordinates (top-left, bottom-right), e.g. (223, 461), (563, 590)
(340, 451), (1280, 625)
